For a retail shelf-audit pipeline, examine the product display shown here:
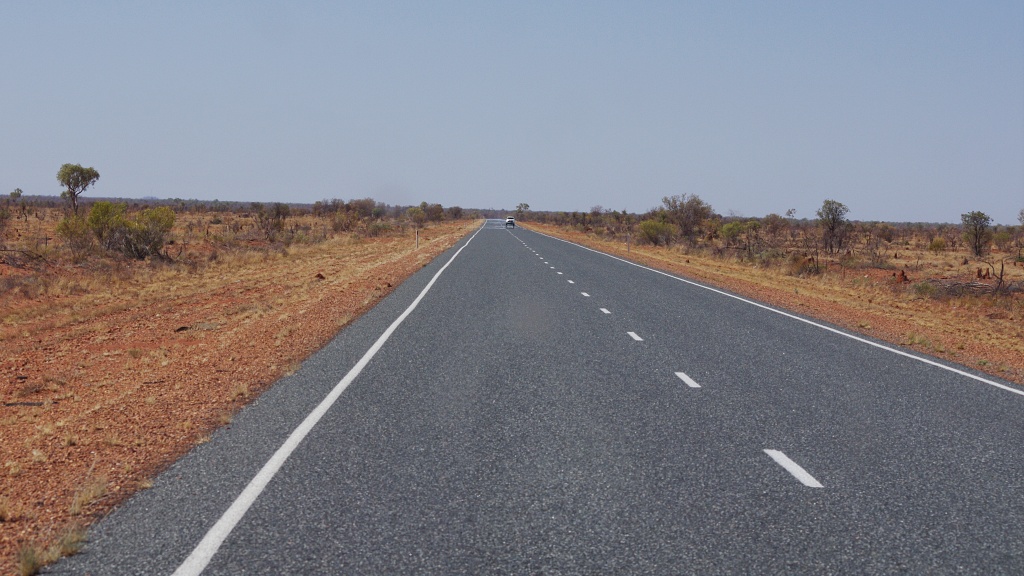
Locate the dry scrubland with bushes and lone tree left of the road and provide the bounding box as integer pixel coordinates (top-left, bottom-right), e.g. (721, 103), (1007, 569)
(0, 164), (479, 276)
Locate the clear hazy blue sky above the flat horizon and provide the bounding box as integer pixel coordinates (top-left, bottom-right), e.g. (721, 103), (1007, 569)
(0, 0), (1024, 223)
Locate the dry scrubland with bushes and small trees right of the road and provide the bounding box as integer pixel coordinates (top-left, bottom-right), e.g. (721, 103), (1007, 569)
(519, 195), (1024, 290)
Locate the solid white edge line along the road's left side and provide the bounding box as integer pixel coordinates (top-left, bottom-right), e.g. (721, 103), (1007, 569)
(174, 220), (483, 576)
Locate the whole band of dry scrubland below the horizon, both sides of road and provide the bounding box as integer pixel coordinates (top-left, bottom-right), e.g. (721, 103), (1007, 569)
(0, 164), (1024, 295)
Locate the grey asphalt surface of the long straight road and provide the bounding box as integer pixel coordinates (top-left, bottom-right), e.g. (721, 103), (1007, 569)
(46, 220), (1024, 575)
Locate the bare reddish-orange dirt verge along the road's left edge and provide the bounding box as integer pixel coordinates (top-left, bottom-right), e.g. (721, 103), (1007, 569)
(0, 220), (479, 574)
